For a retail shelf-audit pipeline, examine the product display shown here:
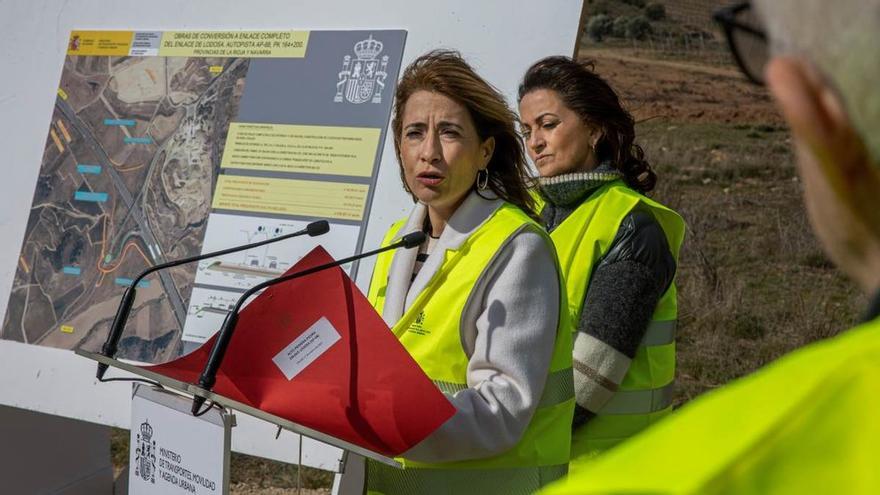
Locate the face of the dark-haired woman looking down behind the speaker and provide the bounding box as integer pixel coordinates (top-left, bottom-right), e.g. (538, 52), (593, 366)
(519, 89), (600, 177)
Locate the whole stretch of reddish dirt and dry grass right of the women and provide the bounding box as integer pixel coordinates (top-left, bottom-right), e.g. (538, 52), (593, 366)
(581, 47), (866, 405)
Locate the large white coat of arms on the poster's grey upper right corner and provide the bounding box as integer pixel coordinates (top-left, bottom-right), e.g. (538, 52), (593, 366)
(333, 34), (388, 104)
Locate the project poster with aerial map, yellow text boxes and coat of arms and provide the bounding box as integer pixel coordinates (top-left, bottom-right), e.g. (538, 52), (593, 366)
(0, 31), (406, 362)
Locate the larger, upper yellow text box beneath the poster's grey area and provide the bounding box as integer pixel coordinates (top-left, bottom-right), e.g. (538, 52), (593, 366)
(220, 122), (381, 177)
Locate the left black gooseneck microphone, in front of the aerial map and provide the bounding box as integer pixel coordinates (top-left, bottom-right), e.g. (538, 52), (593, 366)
(95, 220), (330, 381)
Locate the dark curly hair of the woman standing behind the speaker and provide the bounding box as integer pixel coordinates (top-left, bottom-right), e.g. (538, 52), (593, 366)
(517, 56), (657, 193)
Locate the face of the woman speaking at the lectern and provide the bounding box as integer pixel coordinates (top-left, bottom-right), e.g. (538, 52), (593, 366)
(400, 90), (495, 218)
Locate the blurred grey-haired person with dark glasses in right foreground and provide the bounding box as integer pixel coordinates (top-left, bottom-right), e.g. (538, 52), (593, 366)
(542, 0), (880, 495)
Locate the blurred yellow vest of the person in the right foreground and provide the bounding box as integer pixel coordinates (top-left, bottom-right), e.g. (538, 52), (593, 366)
(541, 319), (880, 495)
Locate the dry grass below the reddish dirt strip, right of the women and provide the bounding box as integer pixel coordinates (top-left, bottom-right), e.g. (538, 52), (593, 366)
(638, 120), (865, 404)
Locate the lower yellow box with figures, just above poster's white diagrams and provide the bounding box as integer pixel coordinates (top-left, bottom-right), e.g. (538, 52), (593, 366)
(211, 175), (369, 221)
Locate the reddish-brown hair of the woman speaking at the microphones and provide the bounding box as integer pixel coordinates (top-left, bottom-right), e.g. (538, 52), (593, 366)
(391, 50), (537, 218)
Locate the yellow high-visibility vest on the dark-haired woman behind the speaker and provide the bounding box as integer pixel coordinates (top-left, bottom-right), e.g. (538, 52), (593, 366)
(550, 181), (685, 458)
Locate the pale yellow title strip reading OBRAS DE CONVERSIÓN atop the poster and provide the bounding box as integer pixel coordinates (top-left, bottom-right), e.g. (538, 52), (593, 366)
(159, 31), (309, 58)
